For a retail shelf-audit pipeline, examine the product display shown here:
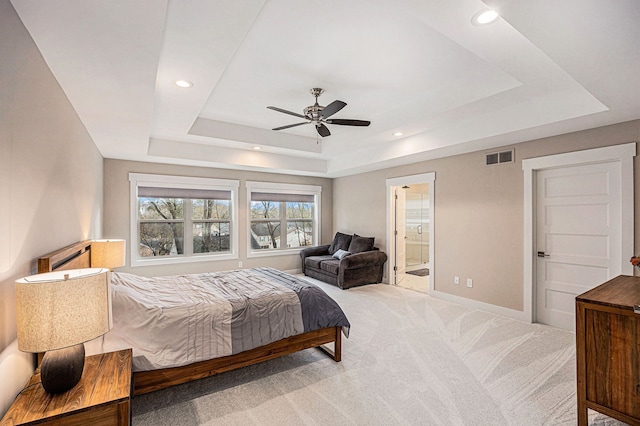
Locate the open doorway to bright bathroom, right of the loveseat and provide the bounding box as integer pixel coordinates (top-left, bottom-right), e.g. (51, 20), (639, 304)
(387, 173), (435, 293)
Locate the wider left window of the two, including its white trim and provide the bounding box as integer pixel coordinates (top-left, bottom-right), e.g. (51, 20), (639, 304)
(129, 173), (239, 266)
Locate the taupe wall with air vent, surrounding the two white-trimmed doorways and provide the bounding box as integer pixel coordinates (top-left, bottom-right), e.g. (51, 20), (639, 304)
(333, 121), (640, 311)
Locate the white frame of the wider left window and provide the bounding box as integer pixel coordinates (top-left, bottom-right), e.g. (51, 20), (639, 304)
(129, 173), (240, 267)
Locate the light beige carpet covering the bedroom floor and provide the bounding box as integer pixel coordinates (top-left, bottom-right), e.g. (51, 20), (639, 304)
(132, 281), (619, 426)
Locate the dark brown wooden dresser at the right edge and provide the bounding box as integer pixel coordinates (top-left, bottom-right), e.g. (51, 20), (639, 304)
(576, 275), (640, 425)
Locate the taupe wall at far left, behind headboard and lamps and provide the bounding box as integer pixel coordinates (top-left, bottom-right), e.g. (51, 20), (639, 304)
(0, 0), (102, 416)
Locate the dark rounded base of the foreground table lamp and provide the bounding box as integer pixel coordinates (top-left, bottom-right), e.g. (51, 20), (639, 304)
(40, 343), (84, 394)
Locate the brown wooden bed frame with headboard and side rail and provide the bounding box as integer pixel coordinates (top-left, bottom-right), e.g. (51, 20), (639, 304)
(38, 240), (342, 395)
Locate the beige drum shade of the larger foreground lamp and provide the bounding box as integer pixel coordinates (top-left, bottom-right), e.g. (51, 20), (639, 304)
(16, 268), (111, 352)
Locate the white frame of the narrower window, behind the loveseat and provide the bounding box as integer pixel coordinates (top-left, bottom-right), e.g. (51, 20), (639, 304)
(245, 181), (322, 258)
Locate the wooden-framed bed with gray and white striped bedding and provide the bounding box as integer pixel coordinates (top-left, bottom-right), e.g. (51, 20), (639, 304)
(38, 240), (350, 395)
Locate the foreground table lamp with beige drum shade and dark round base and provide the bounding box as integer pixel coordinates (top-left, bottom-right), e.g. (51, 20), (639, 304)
(16, 268), (111, 394)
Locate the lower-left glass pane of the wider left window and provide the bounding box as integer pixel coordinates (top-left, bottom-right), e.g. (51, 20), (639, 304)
(139, 222), (184, 257)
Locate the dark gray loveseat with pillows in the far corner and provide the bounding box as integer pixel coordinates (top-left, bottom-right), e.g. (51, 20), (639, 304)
(300, 232), (387, 289)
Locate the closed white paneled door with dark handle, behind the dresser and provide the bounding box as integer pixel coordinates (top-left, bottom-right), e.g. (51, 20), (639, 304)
(535, 162), (622, 330)
